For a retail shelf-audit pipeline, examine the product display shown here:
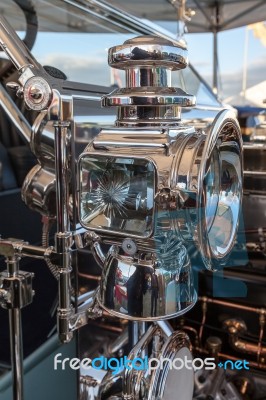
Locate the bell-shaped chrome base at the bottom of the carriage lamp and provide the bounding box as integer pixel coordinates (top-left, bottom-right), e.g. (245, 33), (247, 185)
(99, 238), (196, 320)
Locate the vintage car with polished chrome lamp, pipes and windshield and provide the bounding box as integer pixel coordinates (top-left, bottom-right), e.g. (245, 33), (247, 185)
(0, 0), (266, 400)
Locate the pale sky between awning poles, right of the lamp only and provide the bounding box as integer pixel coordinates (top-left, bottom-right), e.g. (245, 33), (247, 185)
(187, 27), (266, 98)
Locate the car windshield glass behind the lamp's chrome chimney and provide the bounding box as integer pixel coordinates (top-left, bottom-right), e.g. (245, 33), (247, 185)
(2, 0), (220, 106)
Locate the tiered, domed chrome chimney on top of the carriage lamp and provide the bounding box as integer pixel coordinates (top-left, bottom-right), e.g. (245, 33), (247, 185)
(102, 36), (196, 127)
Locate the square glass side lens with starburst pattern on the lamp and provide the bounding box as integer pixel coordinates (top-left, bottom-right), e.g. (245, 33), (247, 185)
(79, 154), (155, 237)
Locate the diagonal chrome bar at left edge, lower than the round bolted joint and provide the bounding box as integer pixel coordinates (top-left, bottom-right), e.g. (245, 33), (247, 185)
(0, 82), (31, 143)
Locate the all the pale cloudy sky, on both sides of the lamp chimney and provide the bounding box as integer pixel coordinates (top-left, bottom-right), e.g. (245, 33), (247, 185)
(29, 21), (266, 103)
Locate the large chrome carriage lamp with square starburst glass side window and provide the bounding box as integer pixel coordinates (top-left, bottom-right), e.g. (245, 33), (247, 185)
(78, 36), (242, 320)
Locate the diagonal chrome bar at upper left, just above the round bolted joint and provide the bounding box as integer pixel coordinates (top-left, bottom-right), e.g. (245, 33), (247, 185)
(0, 15), (42, 72)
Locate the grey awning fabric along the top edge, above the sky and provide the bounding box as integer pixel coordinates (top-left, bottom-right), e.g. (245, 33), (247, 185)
(107, 0), (266, 33)
